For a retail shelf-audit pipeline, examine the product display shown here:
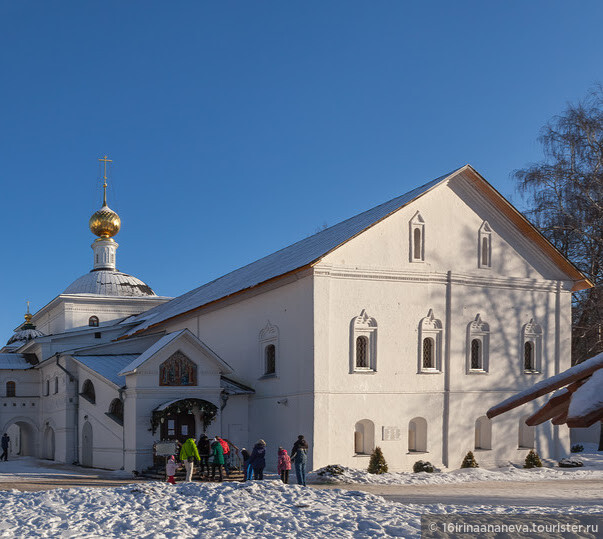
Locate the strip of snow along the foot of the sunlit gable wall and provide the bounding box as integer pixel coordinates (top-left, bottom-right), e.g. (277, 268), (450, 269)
(308, 444), (603, 485)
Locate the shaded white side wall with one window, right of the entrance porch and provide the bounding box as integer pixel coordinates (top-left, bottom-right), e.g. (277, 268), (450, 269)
(167, 276), (314, 470)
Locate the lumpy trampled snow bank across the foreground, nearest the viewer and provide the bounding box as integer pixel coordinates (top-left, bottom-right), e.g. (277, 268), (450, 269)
(0, 480), (603, 538)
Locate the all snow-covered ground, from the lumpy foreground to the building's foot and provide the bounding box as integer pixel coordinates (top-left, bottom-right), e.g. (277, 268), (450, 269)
(0, 448), (603, 538)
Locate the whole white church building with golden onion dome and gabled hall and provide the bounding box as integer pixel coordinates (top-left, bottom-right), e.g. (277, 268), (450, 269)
(0, 165), (592, 471)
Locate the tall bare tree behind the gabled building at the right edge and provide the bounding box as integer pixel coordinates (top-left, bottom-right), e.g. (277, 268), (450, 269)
(514, 85), (603, 364)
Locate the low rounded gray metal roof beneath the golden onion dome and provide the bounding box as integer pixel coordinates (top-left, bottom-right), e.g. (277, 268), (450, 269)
(63, 270), (156, 297)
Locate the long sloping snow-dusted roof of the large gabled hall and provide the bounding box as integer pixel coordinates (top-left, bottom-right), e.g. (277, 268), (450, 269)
(129, 169), (460, 334)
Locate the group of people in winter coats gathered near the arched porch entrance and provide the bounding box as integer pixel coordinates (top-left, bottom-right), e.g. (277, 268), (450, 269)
(166, 434), (308, 486)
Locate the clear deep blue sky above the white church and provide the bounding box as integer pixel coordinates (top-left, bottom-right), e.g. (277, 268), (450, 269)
(0, 0), (603, 341)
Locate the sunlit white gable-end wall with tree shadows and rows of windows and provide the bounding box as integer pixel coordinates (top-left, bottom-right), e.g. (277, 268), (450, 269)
(314, 175), (571, 470)
